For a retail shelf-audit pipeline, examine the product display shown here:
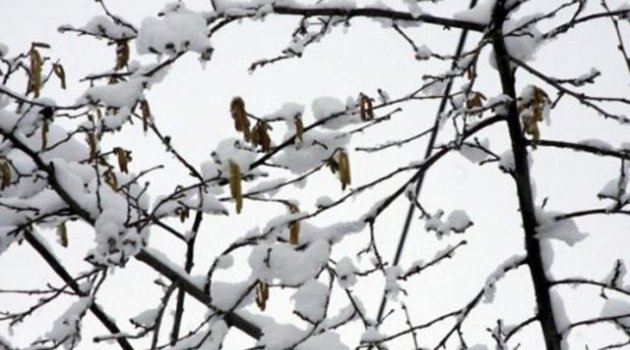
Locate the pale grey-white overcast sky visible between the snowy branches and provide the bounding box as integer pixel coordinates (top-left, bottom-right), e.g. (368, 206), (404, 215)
(0, 0), (630, 350)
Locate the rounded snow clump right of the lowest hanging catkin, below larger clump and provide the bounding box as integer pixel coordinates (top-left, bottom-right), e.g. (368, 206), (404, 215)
(291, 280), (328, 323)
